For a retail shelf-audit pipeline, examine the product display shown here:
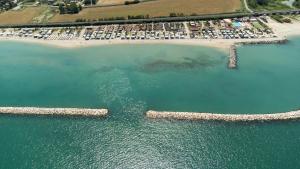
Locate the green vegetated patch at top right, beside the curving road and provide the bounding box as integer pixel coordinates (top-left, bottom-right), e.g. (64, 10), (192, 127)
(247, 0), (291, 11)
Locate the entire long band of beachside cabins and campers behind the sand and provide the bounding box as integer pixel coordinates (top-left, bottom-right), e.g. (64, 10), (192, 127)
(0, 18), (276, 40)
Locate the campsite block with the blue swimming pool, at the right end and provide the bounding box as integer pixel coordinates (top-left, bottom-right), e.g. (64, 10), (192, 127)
(188, 18), (275, 39)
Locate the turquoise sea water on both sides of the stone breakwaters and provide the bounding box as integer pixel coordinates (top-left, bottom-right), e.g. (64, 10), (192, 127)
(0, 38), (300, 169)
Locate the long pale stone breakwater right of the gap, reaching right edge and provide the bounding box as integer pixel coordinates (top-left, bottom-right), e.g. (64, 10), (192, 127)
(146, 110), (300, 122)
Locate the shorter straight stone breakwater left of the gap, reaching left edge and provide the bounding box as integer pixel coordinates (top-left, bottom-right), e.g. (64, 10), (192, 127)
(0, 107), (108, 117)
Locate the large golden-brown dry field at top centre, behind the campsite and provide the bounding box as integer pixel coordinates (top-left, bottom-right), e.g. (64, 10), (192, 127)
(51, 0), (242, 22)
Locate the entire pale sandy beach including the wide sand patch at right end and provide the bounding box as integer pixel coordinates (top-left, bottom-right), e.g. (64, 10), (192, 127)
(0, 19), (300, 50)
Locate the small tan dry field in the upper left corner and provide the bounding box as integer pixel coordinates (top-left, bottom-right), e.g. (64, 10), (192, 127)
(0, 6), (47, 24)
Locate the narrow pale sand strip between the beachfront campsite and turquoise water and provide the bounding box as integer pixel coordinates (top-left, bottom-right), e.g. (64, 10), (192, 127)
(0, 36), (292, 50)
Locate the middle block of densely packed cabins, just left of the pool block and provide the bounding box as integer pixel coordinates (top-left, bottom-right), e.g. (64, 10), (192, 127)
(83, 22), (188, 40)
